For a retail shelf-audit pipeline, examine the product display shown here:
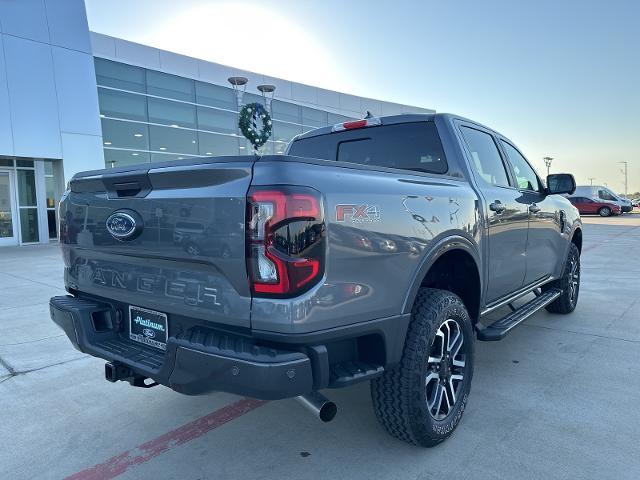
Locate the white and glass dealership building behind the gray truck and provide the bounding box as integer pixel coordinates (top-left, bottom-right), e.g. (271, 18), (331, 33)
(0, 0), (433, 247)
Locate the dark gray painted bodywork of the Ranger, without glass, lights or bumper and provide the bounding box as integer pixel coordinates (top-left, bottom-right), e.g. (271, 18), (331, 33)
(61, 114), (580, 334)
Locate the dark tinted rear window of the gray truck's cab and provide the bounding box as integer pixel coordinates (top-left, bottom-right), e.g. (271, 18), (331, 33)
(289, 122), (447, 173)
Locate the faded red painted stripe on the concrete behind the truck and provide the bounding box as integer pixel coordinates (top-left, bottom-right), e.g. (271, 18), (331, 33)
(65, 398), (266, 480)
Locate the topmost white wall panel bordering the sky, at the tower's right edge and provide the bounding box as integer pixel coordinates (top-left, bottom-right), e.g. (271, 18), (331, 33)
(45, 0), (91, 53)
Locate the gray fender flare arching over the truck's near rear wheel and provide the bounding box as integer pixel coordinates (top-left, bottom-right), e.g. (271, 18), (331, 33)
(402, 235), (484, 314)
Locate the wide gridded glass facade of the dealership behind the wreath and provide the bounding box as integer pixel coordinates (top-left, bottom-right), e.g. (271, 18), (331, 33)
(95, 58), (358, 167)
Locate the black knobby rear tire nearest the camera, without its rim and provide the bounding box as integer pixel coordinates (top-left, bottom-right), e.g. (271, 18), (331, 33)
(371, 288), (474, 447)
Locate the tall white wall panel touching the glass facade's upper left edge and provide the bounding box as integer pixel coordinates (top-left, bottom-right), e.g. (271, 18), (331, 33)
(52, 47), (102, 135)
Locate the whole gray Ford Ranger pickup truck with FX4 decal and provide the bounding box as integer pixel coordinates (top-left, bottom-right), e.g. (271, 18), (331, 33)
(50, 114), (582, 446)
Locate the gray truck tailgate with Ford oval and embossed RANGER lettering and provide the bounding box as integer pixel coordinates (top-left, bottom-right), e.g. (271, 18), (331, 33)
(60, 157), (256, 327)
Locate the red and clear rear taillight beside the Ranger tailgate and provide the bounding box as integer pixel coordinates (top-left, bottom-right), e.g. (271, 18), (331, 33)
(247, 186), (325, 297)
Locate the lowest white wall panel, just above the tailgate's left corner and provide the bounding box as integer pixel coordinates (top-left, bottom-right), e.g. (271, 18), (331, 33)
(62, 133), (104, 182)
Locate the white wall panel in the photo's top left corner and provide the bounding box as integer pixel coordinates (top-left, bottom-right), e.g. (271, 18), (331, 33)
(0, 0), (49, 42)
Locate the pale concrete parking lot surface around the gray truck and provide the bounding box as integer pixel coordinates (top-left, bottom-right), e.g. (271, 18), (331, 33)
(0, 214), (640, 480)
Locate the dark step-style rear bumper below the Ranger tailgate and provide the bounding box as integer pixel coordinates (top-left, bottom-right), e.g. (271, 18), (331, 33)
(49, 296), (314, 400)
